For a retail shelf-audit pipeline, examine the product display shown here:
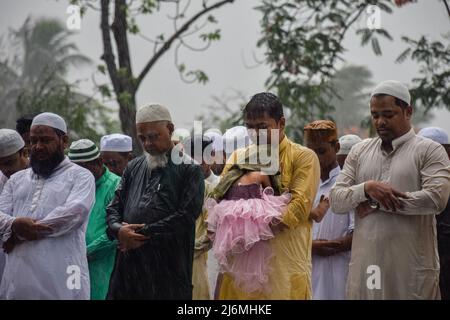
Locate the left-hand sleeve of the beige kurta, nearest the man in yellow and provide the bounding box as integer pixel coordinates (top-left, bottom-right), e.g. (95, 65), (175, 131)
(330, 147), (367, 214)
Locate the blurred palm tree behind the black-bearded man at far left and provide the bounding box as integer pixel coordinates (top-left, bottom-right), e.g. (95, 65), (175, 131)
(0, 18), (118, 141)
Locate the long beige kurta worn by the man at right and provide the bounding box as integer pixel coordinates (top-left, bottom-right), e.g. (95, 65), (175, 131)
(330, 130), (450, 299)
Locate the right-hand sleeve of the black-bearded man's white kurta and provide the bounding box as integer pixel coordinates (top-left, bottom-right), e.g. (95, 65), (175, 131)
(38, 170), (95, 237)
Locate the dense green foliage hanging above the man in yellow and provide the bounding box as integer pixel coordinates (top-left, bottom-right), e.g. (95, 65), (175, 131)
(257, 0), (396, 141)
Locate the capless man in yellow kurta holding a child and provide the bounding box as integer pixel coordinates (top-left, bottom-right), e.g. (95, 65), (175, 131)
(219, 93), (320, 300)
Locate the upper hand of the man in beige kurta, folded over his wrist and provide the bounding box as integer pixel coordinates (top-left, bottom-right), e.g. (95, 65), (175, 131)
(364, 180), (408, 211)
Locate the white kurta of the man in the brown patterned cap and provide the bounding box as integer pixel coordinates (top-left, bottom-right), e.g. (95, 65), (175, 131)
(312, 166), (354, 300)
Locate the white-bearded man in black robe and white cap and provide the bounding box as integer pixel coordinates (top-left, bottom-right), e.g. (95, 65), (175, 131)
(107, 104), (204, 300)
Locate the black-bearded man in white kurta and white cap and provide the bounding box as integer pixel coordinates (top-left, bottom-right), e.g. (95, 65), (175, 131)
(0, 112), (95, 300)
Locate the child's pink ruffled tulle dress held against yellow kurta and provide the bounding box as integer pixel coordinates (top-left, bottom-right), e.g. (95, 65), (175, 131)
(206, 183), (291, 293)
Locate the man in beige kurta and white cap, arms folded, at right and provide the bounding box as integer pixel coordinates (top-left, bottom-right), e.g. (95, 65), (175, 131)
(330, 80), (450, 300)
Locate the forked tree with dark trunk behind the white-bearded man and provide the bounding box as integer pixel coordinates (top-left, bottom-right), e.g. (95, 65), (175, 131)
(71, 0), (234, 154)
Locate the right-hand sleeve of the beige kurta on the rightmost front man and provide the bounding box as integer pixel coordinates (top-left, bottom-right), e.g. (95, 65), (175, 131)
(381, 146), (450, 215)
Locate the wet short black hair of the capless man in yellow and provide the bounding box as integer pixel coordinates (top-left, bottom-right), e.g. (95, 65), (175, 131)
(242, 92), (284, 122)
